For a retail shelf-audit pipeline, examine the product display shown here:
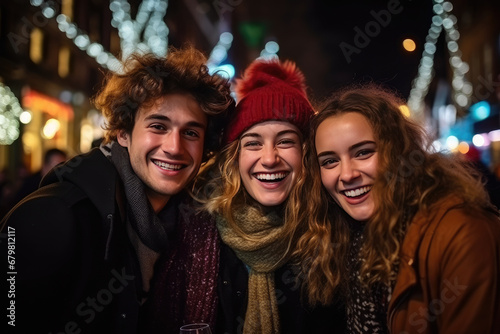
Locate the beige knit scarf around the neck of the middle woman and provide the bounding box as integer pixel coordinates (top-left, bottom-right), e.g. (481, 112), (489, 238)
(217, 205), (288, 334)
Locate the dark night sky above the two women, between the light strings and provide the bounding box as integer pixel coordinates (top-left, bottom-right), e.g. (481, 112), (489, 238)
(227, 0), (434, 102)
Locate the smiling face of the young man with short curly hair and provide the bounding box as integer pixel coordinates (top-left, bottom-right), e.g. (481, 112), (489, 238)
(117, 93), (207, 212)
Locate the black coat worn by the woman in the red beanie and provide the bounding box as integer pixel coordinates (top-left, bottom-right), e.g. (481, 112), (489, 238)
(215, 243), (346, 334)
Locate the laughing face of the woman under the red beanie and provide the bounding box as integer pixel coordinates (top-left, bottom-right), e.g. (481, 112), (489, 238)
(238, 121), (302, 206)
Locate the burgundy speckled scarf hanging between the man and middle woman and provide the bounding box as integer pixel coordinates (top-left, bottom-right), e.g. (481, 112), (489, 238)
(141, 200), (219, 334)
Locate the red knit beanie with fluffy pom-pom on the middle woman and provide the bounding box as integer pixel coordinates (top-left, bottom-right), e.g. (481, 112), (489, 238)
(224, 59), (314, 144)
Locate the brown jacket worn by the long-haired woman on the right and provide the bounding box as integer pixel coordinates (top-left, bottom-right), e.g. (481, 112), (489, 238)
(388, 198), (500, 334)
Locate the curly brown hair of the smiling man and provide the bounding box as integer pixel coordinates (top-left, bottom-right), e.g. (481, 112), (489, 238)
(94, 46), (235, 161)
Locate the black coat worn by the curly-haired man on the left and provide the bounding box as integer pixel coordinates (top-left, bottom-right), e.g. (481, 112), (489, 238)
(1, 149), (142, 334)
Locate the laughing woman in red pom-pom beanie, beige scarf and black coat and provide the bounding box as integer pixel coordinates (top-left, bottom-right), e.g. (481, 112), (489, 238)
(196, 60), (344, 334)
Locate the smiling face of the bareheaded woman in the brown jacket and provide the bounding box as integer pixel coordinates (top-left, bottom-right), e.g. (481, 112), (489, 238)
(315, 112), (378, 221)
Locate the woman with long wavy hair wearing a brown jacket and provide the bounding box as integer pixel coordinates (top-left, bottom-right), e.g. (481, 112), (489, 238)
(295, 85), (500, 333)
